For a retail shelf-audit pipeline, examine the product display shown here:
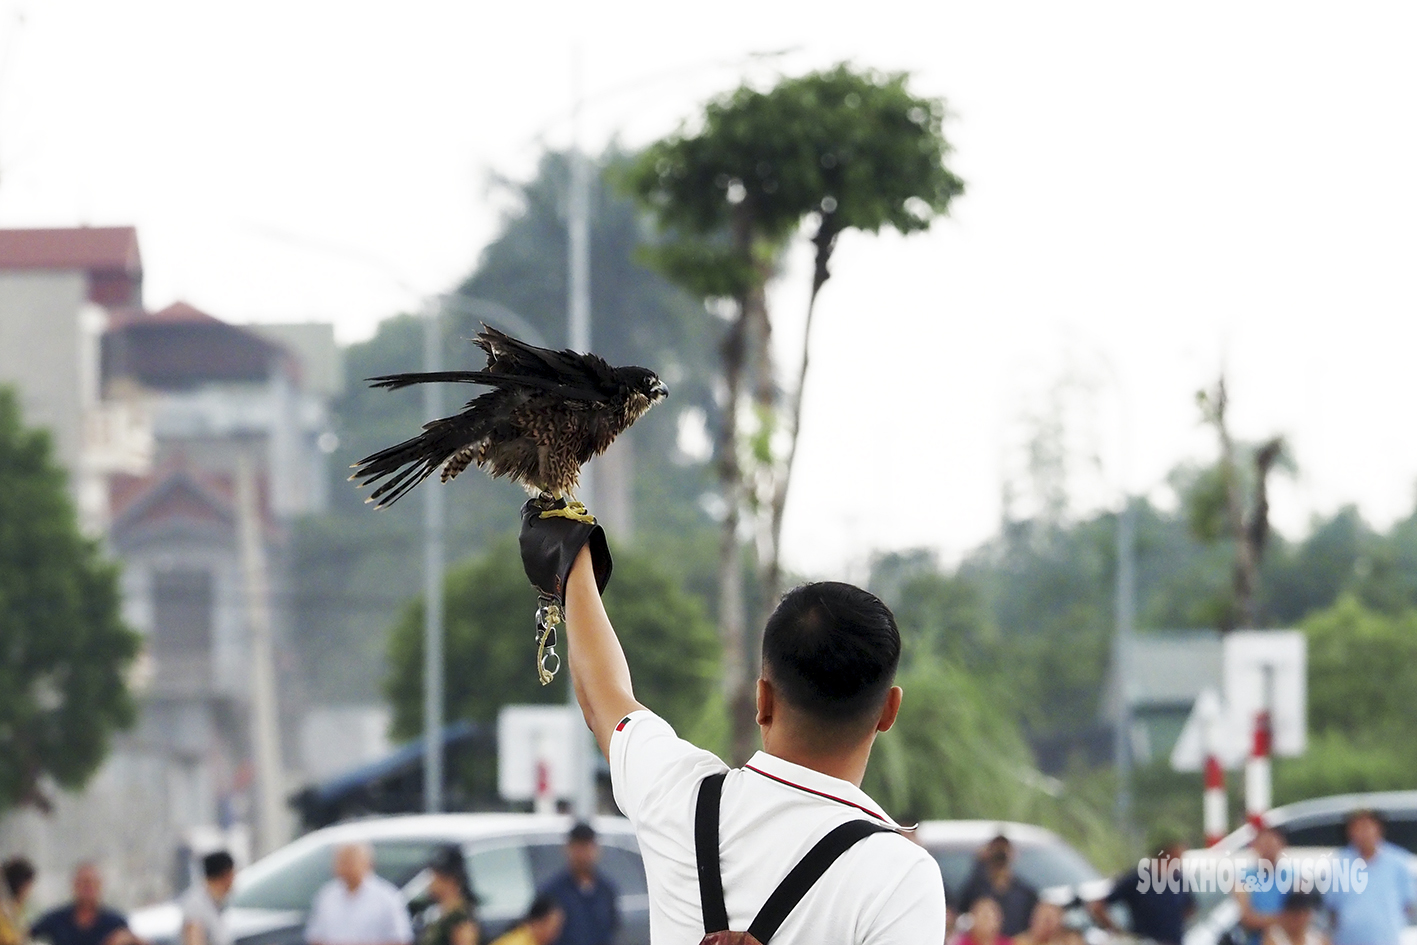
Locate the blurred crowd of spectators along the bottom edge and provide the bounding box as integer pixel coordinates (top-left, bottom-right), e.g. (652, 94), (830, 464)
(0, 810), (1417, 945)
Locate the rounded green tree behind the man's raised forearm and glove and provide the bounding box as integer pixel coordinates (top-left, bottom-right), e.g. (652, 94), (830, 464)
(385, 540), (718, 738)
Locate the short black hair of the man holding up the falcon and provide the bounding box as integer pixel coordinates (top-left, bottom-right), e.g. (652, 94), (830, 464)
(762, 581), (900, 725)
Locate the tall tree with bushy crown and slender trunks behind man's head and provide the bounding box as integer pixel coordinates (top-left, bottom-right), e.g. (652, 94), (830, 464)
(626, 64), (964, 759)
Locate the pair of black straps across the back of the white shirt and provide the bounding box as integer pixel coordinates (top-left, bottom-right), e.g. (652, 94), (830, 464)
(694, 772), (894, 945)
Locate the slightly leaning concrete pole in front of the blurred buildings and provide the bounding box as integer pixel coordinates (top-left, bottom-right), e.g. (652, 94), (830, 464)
(237, 451), (286, 856)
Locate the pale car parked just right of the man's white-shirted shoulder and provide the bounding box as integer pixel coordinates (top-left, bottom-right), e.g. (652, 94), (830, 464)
(915, 820), (1112, 929)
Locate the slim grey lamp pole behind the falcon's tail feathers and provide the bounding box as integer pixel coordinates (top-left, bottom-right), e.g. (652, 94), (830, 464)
(422, 296), (444, 813)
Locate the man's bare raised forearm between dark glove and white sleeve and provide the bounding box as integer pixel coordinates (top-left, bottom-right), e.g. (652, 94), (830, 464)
(565, 547), (643, 757)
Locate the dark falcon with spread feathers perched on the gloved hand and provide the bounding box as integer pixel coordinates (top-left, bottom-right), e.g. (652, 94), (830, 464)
(350, 326), (669, 521)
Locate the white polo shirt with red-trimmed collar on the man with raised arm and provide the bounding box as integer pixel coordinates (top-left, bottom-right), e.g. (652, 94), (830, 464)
(609, 710), (945, 945)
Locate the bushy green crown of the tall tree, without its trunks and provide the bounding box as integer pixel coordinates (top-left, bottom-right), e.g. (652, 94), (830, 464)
(622, 64), (964, 296)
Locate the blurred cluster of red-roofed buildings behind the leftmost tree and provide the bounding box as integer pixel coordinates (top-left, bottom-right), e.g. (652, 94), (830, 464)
(0, 228), (340, 904)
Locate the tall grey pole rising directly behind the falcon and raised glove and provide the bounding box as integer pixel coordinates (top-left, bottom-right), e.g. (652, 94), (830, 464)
(565, 50), (595, 819)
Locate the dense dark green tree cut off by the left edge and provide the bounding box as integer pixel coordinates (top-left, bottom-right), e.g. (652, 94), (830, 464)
(0, 388), (139, 810)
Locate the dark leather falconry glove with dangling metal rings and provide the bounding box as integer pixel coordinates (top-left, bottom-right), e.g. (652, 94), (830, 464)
(520, 499), (614, 686)
